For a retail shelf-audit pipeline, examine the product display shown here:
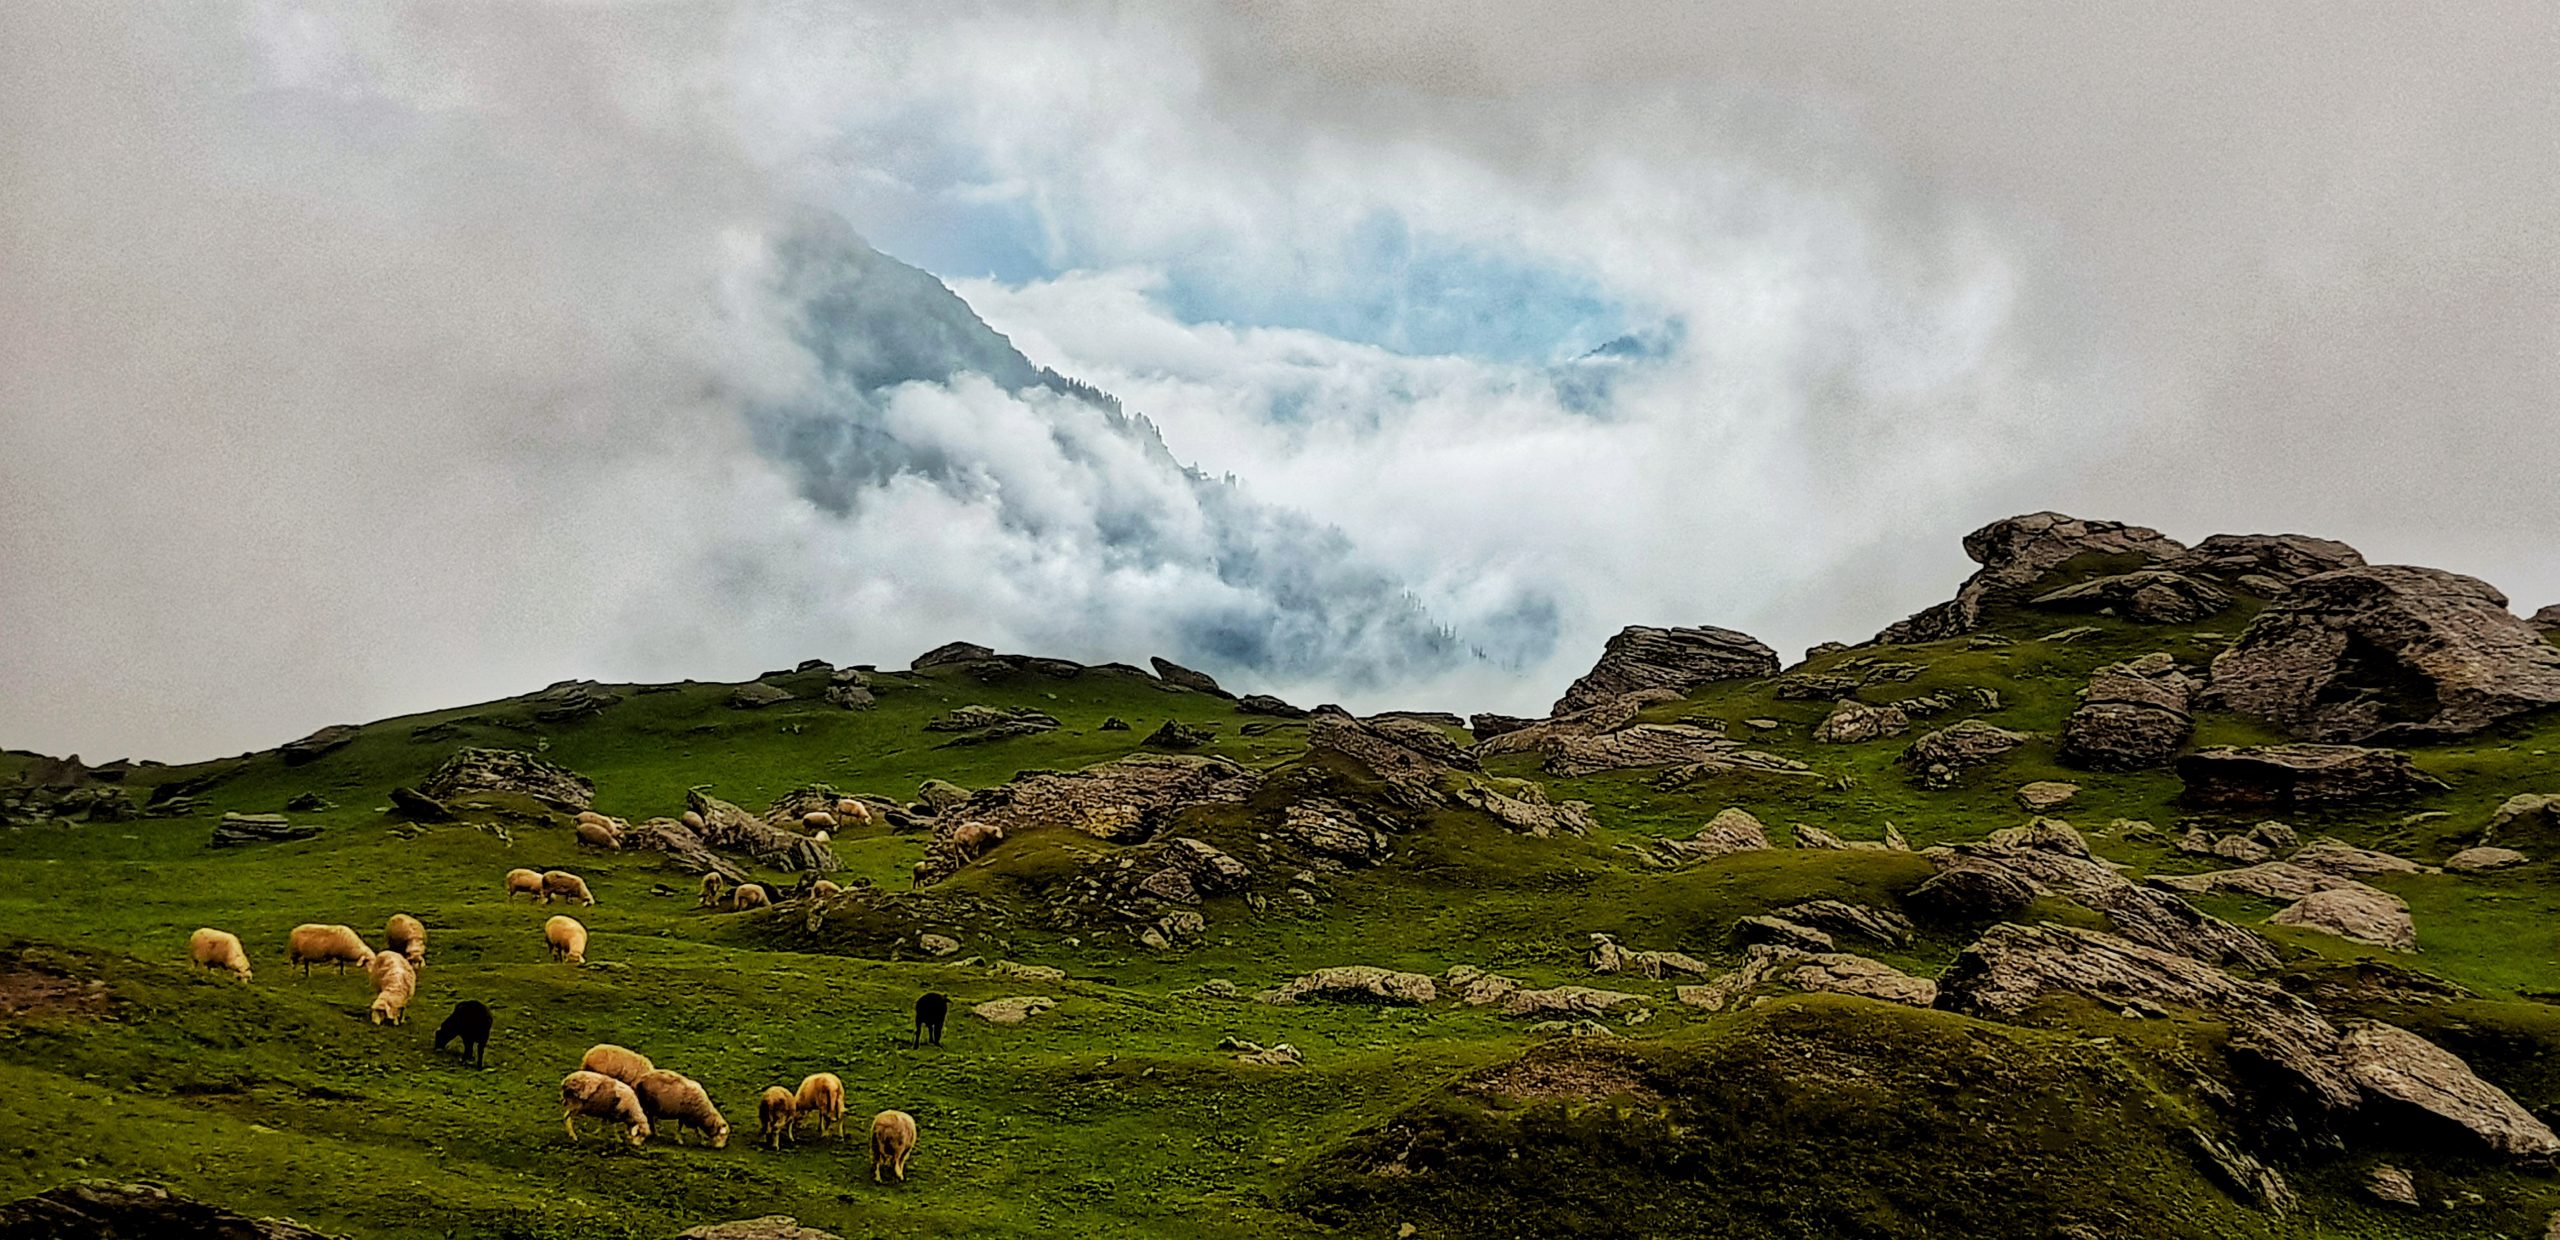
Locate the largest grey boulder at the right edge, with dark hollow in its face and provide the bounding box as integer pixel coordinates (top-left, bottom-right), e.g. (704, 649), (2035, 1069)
(2209, 566), (2560, 740)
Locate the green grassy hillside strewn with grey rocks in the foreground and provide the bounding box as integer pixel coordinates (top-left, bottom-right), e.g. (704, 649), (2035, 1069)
(0, 512), (2560, 1240)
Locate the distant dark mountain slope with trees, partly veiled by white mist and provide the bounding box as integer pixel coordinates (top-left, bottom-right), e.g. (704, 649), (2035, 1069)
(748, 215), (1472, 687)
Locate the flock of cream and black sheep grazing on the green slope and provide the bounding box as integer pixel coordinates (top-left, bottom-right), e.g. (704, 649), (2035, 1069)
(187, 802), (947, 1184)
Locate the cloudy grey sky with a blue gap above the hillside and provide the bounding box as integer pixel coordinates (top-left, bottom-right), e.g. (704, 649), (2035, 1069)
(0, 0), (2560, 761)
